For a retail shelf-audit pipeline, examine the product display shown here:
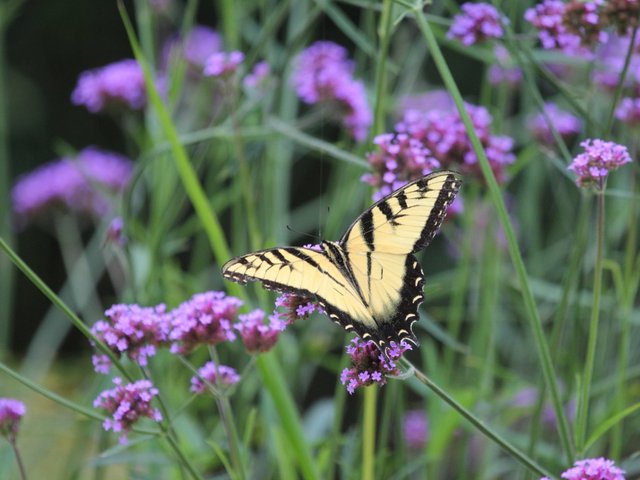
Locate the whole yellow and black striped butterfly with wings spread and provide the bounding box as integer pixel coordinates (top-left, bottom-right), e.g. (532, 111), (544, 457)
(222, 171), (461, 353)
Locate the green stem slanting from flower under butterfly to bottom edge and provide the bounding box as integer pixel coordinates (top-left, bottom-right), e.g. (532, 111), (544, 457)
(408, 358), (552, 478)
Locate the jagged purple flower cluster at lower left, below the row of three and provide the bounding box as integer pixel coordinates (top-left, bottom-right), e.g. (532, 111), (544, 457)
(93, 377), (162, 444)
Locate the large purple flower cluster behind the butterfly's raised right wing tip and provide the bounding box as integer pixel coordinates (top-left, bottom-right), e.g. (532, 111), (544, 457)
(363, 98), (515, 199)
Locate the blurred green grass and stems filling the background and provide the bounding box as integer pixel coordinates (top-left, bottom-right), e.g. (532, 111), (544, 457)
(0, 0), (640, 479)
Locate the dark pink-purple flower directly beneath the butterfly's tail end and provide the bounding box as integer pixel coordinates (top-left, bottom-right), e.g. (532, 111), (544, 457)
(340, 338), (411, 394)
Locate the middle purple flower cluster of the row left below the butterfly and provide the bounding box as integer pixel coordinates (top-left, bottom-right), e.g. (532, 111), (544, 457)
(169, 292), (242, 353)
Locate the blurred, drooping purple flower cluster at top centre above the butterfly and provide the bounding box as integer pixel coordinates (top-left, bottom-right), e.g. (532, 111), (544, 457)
(292, 42), (373, 142)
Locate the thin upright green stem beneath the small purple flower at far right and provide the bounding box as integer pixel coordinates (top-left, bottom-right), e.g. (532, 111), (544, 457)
(576, 190), (605, 453)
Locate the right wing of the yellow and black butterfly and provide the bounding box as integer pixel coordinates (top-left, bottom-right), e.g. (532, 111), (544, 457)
(340, 171), (461, 350)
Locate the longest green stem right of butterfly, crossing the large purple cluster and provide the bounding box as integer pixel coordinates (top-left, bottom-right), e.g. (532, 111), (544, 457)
(414, 10), (574, 463)
